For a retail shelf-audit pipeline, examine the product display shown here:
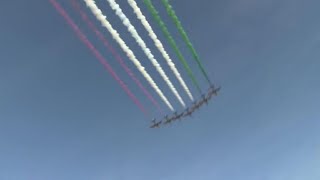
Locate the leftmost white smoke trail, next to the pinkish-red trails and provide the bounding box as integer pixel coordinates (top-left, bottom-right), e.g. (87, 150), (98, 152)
(84, 0), (174, 111)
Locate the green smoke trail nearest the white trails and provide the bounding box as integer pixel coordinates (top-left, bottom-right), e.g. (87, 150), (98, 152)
(144, 0), (202, 94)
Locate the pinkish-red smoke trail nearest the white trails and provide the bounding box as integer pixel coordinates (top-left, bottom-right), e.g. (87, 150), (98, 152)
(71, 0), (162, 112)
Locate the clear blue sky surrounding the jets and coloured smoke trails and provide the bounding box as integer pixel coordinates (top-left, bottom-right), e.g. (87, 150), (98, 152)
(0, 0), (320, 180)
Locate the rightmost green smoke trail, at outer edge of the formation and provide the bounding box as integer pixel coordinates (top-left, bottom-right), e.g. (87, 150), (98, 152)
(162, 0), (211, 84)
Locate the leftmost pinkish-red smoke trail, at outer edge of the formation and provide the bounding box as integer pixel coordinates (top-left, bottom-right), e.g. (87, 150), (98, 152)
(49, 0), (147, 115)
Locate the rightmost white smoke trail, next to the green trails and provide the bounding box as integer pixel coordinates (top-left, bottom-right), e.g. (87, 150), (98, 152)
(128, 0), (194, 101)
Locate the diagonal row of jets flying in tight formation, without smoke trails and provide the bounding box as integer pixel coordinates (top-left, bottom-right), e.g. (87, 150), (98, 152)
(150, 86), (220, 128)
